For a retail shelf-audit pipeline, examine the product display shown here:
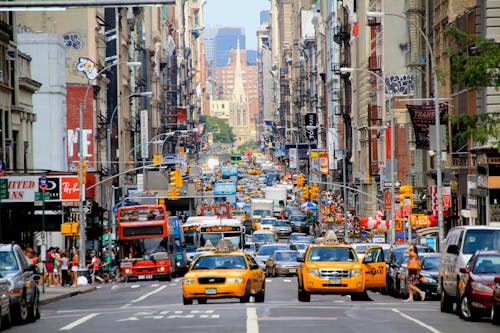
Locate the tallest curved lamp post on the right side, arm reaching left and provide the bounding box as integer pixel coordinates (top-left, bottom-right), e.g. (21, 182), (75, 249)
(366, 12), (445, 247)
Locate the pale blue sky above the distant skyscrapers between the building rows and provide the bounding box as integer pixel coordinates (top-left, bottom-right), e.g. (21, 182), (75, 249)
(204, 0), (271, 50)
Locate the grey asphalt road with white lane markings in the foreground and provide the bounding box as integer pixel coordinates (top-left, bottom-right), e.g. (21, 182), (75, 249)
(8, 277), (500, 333)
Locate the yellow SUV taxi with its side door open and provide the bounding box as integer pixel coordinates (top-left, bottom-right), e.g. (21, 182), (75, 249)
(297, 233), (386, 302)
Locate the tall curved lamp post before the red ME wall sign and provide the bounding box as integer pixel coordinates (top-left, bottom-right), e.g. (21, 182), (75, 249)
(78, 61), (142, 272)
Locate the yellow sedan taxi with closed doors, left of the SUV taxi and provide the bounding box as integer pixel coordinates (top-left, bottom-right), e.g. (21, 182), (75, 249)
(182, 240), (266, 305)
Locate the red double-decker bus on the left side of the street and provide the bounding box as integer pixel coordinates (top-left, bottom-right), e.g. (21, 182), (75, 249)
(117, 205), (175, 281)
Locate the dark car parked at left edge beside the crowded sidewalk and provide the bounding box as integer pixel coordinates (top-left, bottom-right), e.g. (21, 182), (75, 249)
(0, 244), (40, 324)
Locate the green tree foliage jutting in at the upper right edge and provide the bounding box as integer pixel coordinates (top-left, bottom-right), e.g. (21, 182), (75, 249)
(446, 27), (500, 149)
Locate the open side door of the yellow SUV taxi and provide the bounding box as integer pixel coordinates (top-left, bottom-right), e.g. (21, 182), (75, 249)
(363, 246), (387, 289)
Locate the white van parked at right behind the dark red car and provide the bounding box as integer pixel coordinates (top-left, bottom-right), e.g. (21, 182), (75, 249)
(437, 225), (500, 312)
